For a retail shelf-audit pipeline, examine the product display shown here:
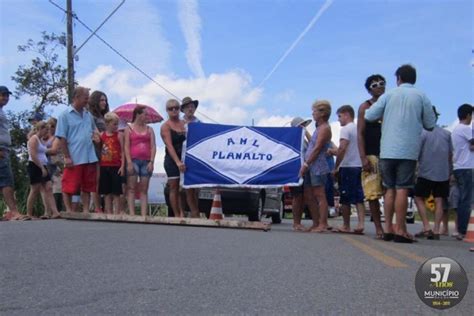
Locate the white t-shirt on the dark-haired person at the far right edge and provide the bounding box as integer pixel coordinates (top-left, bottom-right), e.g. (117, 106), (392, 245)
(451, 123), (474, 170)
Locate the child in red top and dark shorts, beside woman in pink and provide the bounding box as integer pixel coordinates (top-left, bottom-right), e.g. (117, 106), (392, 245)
(99, 112), (125, 214)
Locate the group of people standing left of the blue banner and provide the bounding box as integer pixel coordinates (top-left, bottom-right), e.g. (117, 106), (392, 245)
(0, 86), (199, 220)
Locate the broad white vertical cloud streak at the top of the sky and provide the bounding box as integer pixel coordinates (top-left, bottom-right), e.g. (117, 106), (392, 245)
(178, 0), (204, 78)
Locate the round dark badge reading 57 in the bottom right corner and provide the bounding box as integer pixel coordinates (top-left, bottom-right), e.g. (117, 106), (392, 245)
(415, 257), (468, 309)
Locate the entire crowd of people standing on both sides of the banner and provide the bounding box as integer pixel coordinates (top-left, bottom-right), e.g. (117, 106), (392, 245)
(0, 65), (474, 243)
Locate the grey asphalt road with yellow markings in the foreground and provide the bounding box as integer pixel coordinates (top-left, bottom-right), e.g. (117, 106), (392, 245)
(0, 216), (474, 315)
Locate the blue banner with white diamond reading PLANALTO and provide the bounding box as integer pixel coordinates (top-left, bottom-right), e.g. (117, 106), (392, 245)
(183, 123), (303, 188)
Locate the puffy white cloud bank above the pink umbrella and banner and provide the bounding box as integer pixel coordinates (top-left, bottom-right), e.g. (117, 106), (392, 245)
(85, 65), (264, 125)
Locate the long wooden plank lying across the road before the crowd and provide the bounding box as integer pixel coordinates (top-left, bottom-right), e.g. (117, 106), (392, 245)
(61, 212), (271, 231)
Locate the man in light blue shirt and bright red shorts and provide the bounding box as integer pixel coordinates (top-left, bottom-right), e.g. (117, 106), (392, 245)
(56, 87), (100, 213)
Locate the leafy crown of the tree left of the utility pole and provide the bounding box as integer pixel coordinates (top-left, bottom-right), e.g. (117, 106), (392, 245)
(11, 32), (67, 114)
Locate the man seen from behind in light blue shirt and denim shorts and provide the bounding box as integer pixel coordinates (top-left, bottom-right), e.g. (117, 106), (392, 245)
(365, 65), (436, 243)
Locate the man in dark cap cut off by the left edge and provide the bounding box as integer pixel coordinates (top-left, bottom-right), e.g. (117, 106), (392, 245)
(0, 86), (21, 220)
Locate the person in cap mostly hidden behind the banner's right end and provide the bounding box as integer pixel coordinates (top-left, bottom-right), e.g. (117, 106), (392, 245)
(290, 117), (318, 232)
